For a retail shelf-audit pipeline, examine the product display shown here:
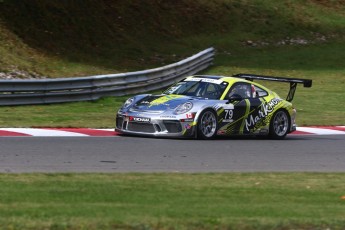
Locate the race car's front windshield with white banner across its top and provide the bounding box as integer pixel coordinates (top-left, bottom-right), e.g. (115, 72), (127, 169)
(164, 78), (228, 99)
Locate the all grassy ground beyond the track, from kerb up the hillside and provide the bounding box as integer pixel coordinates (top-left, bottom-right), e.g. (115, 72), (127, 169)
(0, 0), (345, 128)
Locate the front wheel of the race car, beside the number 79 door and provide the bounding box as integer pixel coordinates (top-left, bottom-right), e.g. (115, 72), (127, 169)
(197, 109), (218, 140)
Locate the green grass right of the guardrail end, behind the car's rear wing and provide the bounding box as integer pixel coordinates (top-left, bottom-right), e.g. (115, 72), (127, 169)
(208, 41), (345, 125)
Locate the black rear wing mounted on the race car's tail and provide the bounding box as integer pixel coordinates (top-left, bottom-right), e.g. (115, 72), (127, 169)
(233, 73), (312, 101)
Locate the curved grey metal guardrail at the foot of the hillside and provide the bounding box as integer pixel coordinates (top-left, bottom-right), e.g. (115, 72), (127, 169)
(0, 48), (215, 105)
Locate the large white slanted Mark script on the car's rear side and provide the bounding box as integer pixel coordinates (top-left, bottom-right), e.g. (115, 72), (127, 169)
(245, 98), (282, 131)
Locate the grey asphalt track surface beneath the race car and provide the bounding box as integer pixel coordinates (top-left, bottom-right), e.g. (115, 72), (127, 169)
(0, 135), (345, 173)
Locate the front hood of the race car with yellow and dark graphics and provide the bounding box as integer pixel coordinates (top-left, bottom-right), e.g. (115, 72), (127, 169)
(133, 94), (194, 111)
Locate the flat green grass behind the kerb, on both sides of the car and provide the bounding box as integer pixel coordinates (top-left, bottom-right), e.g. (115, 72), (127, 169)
(0, 41), (345, 128)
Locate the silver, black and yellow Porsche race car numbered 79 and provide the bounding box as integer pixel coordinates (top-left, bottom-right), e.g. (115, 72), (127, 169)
(115, 74), (312, 139)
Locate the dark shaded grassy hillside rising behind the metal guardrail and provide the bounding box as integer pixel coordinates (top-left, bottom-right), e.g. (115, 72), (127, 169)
(0, 0), (345, 78)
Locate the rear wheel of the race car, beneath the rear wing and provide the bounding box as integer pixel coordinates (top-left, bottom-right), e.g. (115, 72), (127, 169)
(269, 110), (290, 140)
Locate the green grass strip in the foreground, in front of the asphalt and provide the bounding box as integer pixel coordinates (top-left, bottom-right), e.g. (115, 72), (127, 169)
(0, 173), (345, 229)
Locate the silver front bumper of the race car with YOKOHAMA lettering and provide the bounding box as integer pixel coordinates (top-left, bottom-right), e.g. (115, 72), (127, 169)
(115, 114), (195, 137)
